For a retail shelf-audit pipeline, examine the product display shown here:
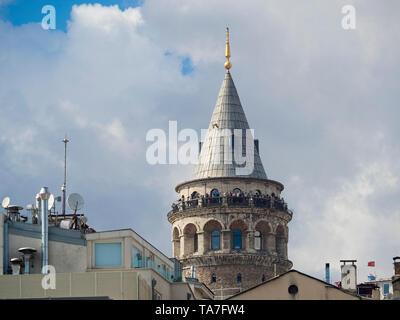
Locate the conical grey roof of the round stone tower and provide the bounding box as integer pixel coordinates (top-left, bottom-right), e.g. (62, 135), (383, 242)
(193, 71), (267, 179)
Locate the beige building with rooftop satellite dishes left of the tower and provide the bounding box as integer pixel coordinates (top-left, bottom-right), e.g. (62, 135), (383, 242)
(0, 188), (214, 300)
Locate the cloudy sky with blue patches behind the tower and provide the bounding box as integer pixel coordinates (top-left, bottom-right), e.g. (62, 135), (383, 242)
(0, 0), (400, 282)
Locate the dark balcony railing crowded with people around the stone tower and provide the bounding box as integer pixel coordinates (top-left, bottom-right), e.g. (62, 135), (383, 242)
(168, 196), (293, 216)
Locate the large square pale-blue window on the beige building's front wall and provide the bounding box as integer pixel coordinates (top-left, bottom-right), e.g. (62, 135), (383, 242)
(94, 242), (122, 267)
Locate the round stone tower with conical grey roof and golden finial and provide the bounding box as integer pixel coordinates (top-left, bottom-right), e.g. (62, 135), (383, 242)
(168, 29), (292, 299)
